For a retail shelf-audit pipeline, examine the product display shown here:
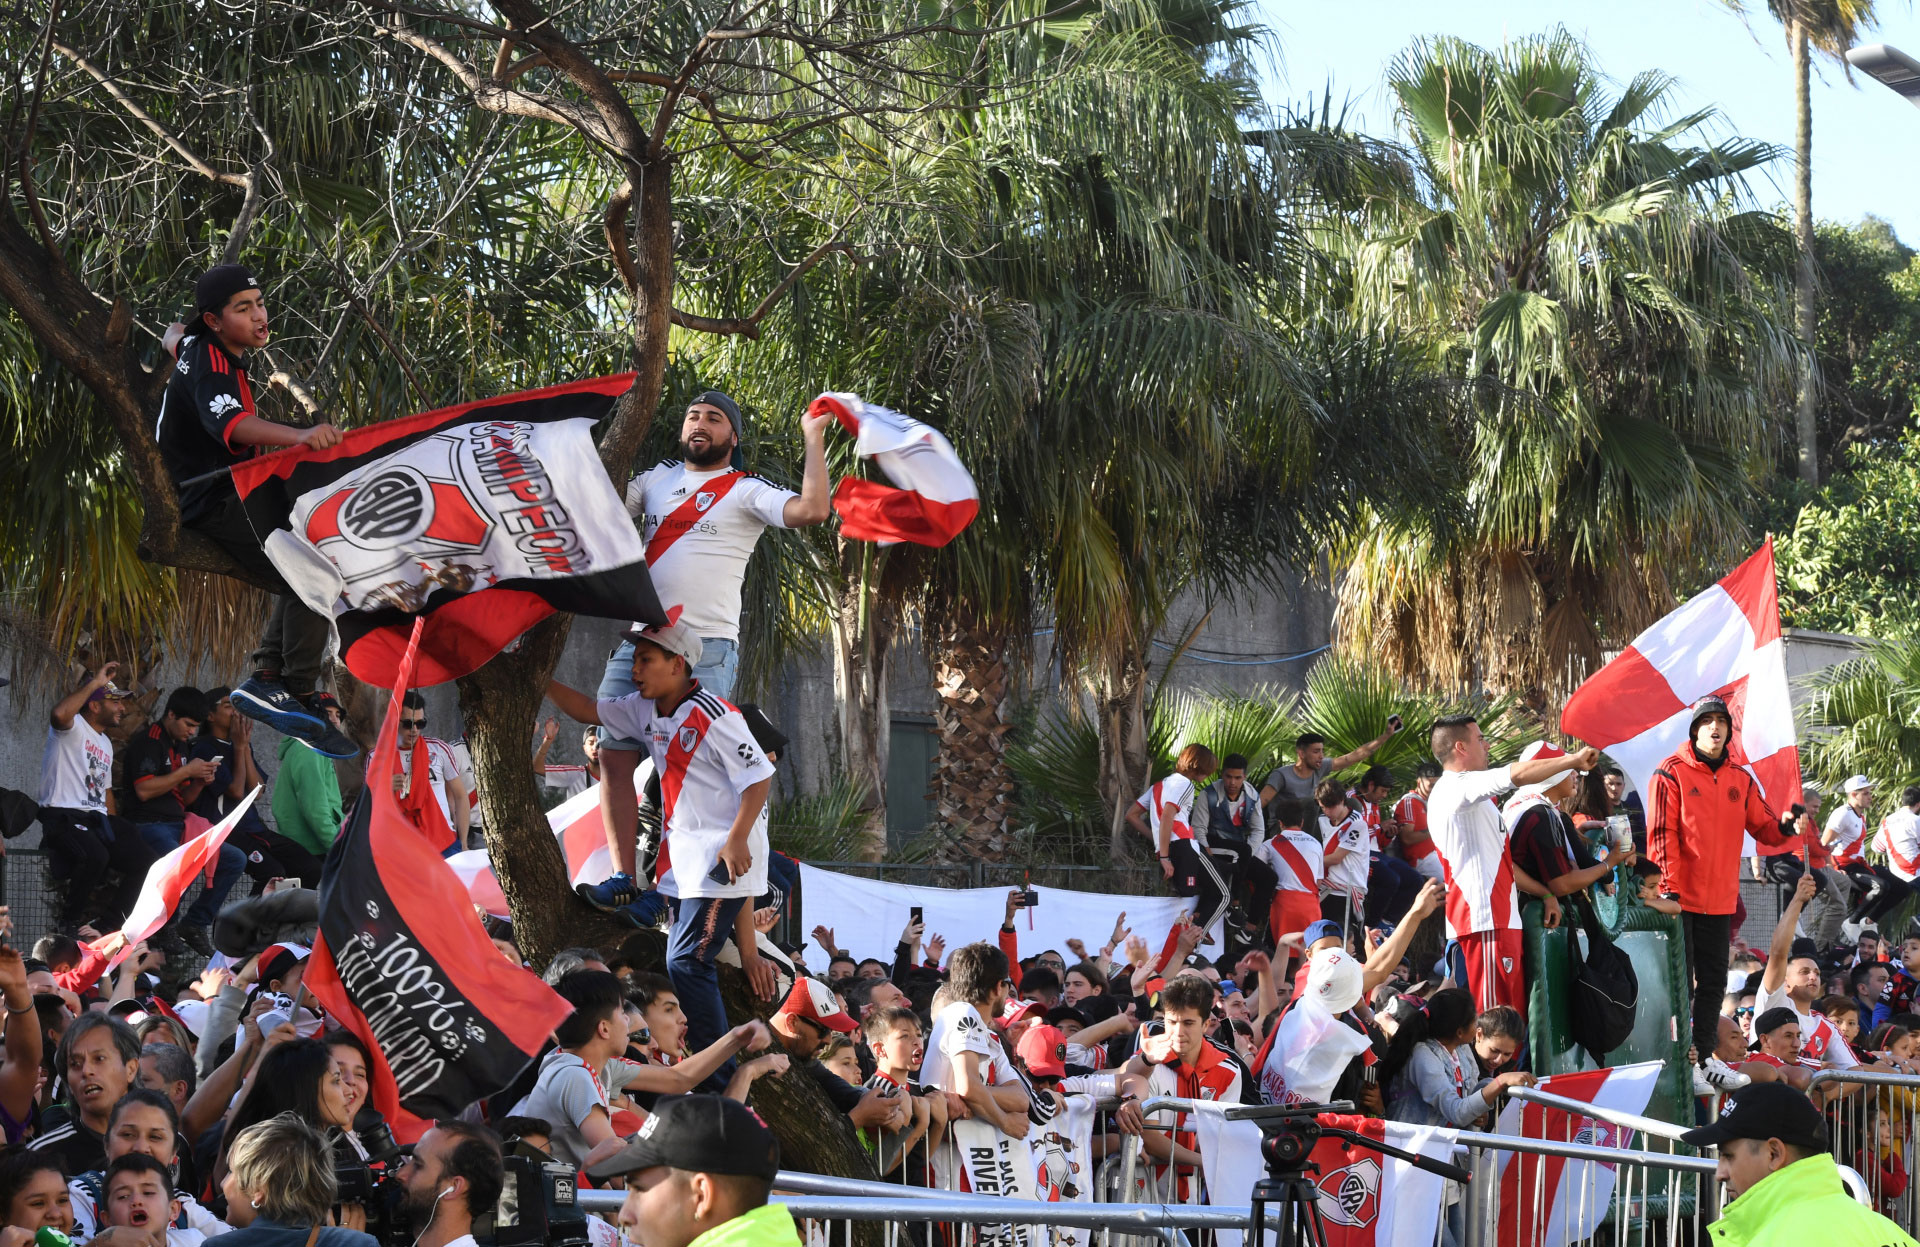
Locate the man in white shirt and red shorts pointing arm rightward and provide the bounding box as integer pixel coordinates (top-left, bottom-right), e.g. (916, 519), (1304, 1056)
(1427, 715), (1599, 1016)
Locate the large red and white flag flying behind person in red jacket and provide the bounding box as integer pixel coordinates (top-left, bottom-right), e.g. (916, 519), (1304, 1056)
(1561, 538), (1801, 811)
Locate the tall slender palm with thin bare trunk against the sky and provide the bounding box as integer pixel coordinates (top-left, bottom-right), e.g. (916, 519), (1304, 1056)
(1722, 0), (1880, 486)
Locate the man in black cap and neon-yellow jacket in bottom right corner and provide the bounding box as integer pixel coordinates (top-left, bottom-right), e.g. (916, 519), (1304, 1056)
(1689, 1082), (1916, 1247)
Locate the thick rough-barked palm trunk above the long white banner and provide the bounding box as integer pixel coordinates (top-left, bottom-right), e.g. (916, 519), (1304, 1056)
(931, 615), (1014, 861)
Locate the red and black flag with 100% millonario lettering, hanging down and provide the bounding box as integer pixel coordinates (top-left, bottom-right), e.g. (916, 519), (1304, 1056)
(303, 619), (572, 1143)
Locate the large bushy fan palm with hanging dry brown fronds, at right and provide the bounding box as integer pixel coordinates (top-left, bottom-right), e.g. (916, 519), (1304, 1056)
(1336, 31), (1805, 697)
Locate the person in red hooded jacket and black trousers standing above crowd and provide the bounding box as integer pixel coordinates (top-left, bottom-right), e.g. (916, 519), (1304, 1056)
(1647, 694), (1803, 1091)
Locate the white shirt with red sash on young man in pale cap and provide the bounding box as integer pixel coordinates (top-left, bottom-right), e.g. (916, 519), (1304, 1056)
(597, 686), (774, 897)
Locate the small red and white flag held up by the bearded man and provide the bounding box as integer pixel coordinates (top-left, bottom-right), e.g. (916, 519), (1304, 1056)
(806, 394), (979, 546)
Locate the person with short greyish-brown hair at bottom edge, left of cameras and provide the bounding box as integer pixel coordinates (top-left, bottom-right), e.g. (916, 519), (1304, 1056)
(221, 1113), (378, 1247)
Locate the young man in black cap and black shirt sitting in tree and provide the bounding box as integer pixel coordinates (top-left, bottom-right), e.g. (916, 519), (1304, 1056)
(154, 263), (359, 757)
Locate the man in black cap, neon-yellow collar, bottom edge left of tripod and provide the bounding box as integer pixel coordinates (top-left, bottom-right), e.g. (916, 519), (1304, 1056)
(588, 1095), (801, 1247)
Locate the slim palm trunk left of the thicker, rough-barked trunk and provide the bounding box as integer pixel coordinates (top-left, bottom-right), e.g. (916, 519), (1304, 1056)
(833, 544), (899, 861)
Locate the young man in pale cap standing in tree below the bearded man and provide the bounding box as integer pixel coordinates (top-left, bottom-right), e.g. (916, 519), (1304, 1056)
(547, 623), (774, 1078)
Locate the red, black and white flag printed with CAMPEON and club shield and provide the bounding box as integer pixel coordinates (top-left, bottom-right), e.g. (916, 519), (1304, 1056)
(232, 373), (666, 688)
